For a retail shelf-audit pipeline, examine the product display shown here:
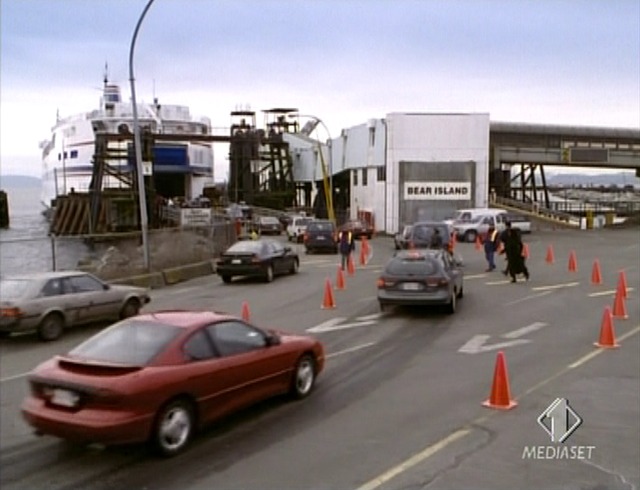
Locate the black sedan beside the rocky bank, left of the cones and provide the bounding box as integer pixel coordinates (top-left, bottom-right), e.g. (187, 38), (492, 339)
(216, 238), (300, 283)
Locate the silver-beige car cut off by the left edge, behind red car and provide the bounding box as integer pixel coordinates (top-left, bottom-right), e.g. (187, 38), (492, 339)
(0, 271), (150, 341)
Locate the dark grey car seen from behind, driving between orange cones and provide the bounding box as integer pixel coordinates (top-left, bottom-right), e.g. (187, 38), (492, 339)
(377, 249), (464, 313)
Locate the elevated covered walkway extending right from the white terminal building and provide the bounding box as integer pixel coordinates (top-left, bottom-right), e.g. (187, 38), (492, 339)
(489, 122), (640, 208)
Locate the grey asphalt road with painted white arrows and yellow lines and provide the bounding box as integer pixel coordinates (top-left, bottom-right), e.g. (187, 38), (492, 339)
(0, 229), (640, 490)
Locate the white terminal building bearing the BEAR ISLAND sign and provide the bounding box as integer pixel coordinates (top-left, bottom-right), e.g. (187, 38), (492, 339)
(286, 113), (490, 233)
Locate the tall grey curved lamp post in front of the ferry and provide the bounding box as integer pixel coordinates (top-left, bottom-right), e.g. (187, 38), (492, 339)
(129, 0), (155, 271)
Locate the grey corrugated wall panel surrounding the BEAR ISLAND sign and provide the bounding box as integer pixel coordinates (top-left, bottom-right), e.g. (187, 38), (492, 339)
(399, 162), (476, 224)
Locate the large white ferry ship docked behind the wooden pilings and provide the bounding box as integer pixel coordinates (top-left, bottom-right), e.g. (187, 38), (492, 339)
(40, 74), (214, 215)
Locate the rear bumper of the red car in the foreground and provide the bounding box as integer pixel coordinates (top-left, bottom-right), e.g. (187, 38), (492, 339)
(22, 396), (153, 444)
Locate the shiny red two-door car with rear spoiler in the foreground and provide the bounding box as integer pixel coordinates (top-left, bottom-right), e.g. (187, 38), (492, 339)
(22, 311), (324, 456)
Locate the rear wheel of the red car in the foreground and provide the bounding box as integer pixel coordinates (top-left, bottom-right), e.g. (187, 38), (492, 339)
(154, 400), (194, 456)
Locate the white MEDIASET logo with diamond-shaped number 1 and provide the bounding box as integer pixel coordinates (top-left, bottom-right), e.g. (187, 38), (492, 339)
(522, 398), (595, 459)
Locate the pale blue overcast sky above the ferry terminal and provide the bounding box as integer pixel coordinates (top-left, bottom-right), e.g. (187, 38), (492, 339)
(0, 0), (640, 180)
